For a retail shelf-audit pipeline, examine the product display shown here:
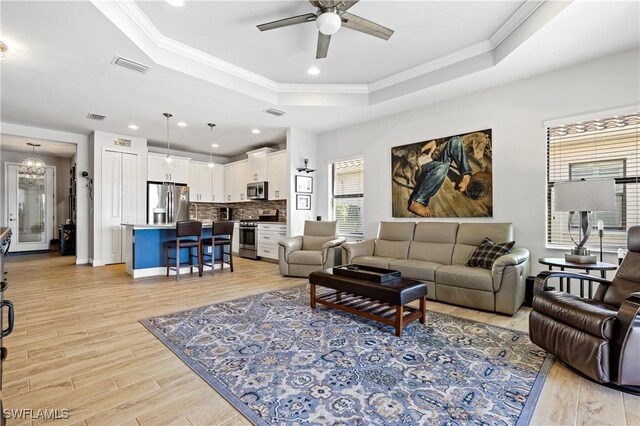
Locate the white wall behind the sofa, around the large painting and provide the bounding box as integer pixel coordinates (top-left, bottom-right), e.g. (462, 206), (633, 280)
(316, 50), (640, 272)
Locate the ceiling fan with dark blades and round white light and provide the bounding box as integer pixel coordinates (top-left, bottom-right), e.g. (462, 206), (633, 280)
(258, 0), (393, 59)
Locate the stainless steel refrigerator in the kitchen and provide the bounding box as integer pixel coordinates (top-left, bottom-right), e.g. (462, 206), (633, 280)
(147, 182), (189, 225)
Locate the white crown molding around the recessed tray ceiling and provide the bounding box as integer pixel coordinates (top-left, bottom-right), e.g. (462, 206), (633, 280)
(91, 0), (560, 106)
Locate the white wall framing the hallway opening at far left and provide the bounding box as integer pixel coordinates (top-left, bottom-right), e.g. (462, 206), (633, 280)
(0, 123), (89, 264)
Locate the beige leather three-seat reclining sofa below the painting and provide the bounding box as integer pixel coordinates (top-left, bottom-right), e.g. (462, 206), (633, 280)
(342, 222), (529, 315)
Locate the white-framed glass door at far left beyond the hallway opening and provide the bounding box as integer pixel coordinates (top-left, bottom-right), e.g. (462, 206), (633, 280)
(5, 163), (56, 251)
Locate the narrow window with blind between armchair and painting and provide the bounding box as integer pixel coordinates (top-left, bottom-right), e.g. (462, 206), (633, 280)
(329, 159), (364, 236)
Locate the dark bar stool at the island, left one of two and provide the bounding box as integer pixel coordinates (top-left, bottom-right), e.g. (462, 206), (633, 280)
(165, 220), (202, 280)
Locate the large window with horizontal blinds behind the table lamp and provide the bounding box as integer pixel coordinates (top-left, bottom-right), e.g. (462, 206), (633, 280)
(547, 112), (640, 250)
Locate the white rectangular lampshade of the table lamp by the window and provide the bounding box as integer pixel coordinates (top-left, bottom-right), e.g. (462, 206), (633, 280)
(554, 178), (616, 212)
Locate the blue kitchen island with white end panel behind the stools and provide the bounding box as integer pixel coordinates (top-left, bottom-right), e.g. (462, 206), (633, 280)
(123, 222), (229, 278)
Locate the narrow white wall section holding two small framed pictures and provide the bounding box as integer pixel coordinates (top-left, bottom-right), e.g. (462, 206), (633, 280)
(287, 128), (318, 236)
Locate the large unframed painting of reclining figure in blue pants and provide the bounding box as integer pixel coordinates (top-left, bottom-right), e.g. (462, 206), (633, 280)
(391, 129), (493, 217)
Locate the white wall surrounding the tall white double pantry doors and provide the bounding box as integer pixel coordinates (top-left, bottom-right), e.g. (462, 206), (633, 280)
(90, 132), (147, 266)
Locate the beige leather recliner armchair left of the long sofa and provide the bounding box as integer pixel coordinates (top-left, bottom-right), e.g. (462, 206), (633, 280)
(278, 220), (345, 277)
